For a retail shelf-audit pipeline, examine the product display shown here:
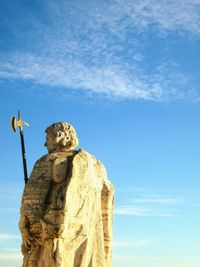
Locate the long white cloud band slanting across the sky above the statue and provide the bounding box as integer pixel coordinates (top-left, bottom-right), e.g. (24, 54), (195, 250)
(0, 54), (191, 101)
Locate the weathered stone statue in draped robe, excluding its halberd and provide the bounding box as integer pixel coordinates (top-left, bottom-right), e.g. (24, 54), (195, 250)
(19, 122), (114, 267)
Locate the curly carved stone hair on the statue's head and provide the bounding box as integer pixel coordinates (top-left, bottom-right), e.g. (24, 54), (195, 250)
(45, 122), (78, 150)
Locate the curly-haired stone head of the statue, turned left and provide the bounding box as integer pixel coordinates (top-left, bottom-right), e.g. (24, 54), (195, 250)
(45, 122), (78, 153)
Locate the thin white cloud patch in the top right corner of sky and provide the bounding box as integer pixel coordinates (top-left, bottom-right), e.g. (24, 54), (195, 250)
(113, 0), (200, 33)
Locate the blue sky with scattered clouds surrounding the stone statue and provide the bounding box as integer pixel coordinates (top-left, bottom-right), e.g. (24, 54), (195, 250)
(0, 0), (200, 267)
